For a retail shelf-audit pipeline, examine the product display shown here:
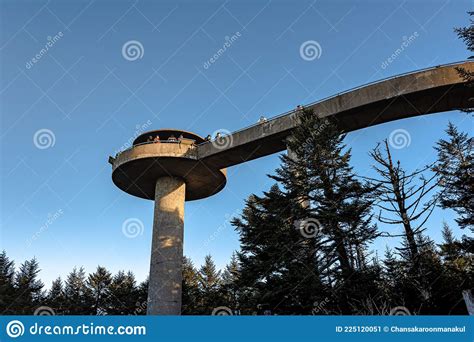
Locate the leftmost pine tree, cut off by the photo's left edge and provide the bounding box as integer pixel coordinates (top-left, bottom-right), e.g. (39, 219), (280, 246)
(0, 251), (16, 315)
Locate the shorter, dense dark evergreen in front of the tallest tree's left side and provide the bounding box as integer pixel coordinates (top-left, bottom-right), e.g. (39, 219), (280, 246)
(232, 185), (326, 314)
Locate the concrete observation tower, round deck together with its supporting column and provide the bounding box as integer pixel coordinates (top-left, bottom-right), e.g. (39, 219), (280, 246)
(109, 129), (226, 315)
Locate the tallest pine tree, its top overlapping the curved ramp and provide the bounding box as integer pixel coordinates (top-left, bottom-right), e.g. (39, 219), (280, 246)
(272, 110), (377, 308)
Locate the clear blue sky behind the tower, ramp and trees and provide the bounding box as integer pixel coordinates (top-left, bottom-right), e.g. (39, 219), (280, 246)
(0, 0), (473, 286)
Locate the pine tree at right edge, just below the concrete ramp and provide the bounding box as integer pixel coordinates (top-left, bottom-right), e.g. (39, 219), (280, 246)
(434, 123), (474, 232)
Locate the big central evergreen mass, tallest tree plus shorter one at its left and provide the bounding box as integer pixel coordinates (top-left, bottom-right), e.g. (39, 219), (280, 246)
(233, 111), (379, 314)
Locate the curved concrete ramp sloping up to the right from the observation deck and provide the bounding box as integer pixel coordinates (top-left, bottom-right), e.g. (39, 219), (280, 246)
(197, 61), (474, 168)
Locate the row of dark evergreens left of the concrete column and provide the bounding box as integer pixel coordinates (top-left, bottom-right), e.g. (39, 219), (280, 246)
(0, 251), (148, 315)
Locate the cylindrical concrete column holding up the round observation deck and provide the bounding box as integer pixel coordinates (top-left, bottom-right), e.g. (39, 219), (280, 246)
(147, 177), (186, 315)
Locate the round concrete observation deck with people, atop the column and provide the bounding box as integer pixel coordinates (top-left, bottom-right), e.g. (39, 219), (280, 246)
(109, 129), (226, 201)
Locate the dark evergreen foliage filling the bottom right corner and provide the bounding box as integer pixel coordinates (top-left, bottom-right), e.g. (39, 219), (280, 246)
(381, 230), (474, 315)
